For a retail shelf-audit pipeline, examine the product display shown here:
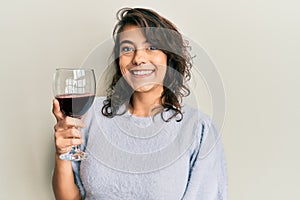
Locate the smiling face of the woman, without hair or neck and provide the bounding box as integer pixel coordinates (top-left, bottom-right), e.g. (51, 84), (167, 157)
(119, 25), (167, 92)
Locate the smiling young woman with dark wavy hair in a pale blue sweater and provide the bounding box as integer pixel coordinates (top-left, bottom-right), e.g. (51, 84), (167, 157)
(53, 8), (227, 200)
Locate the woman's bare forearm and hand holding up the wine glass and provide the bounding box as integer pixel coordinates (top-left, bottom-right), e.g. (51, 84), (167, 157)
(52, 99), (85, 199)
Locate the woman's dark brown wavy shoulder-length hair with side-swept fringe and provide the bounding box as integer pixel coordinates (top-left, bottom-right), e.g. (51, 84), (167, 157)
(102, 8), (192, 122)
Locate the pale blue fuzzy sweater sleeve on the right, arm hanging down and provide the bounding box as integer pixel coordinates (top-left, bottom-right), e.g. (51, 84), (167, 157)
(182, 117), (228, 200)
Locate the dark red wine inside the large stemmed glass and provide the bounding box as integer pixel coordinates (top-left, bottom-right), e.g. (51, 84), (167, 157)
(55, 93), (95, 118)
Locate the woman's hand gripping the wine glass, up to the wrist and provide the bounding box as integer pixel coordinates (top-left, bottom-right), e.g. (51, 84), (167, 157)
(52, 99), (85, 155)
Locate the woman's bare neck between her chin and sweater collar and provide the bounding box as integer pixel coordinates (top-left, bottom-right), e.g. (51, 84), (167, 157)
(129, 87), (163, 116)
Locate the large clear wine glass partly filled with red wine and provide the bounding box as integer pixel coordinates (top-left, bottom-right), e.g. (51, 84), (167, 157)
(53, 68), (96, 161)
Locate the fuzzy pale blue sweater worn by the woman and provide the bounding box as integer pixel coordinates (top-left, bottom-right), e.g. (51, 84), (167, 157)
(72, 97), (227, 200)
